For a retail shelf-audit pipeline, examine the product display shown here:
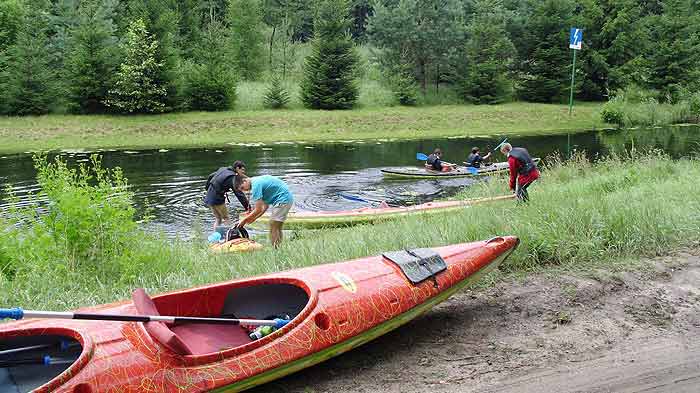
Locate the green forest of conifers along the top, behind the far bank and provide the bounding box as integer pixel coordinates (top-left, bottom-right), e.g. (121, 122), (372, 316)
(0, 0), (700, 116)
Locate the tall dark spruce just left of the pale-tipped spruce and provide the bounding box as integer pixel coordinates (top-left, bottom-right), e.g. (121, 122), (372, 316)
(67, 0), (118, 113)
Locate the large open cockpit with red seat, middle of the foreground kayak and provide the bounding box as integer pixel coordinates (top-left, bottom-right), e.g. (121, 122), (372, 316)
(135, 283), (309, 356)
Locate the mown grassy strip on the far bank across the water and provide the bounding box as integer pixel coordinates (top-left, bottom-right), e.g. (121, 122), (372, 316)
(0, 103), (605, 153)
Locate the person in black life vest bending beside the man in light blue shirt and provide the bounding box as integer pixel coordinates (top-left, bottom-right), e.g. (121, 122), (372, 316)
(204, 161), (250, 230)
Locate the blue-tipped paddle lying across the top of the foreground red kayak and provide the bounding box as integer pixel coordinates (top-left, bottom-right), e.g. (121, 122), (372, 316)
(0, 307), (289, 329)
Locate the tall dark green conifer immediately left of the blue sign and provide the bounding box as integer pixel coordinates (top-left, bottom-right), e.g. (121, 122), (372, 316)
(519, 0), (573, 102)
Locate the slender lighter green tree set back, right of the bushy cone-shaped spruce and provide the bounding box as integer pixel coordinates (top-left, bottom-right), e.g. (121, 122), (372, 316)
(228, 0), (265, 80)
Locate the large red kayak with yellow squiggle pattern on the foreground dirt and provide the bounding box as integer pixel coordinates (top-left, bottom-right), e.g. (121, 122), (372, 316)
(0, 237), (518, 393)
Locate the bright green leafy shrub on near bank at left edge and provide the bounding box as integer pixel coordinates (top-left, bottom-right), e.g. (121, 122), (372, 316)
(0, 155), (164, 280)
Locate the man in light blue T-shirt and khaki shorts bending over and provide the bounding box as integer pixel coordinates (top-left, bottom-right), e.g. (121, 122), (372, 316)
(234, 175), (294, 248)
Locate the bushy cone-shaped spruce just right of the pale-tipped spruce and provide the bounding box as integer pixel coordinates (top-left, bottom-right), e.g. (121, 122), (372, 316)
(185, 22), (236, 111)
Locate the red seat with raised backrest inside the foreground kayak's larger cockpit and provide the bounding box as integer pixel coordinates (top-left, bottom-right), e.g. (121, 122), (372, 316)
(132, 288), (252, 355)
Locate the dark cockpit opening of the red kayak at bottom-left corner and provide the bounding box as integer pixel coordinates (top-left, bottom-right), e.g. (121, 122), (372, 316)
(0, 334), (83, 393)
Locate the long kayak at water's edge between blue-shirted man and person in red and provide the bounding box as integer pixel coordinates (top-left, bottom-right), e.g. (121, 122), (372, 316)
(240, 194), (514, 229)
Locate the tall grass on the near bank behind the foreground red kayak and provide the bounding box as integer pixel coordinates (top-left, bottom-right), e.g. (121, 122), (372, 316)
(0, 151), (700, 309)
